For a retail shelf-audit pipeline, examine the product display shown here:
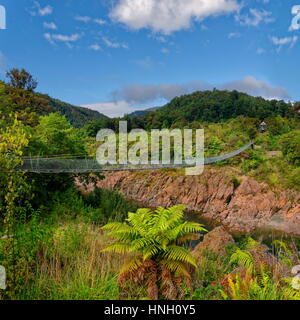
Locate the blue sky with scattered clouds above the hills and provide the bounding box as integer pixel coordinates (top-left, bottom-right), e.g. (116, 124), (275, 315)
(0, 0), (300, 116)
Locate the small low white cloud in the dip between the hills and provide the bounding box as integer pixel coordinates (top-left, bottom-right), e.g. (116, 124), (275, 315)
(81, 101), (135, 118)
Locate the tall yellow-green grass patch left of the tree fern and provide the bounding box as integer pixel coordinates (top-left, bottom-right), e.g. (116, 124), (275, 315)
(19, 222), (123, 300)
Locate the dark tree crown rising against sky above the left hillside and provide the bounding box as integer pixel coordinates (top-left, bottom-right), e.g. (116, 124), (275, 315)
(6, 68), (38, 91)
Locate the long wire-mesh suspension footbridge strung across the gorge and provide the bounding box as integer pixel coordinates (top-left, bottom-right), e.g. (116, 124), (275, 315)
(17, 142), (254, 173)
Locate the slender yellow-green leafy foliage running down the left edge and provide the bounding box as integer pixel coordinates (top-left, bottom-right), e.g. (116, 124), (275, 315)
(0, 116), (30, 298)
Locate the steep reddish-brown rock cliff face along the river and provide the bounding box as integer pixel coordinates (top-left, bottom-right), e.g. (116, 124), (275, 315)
(77, 168), (300, 236)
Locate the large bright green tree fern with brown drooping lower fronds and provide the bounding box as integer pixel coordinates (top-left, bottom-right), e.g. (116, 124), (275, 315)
(102, 206), (206, 299)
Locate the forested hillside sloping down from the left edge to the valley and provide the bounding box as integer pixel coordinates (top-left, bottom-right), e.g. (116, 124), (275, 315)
(0, 81), (107, 128)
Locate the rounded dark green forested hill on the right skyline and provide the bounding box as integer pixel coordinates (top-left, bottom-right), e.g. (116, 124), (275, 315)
(132, 90), (296, 128)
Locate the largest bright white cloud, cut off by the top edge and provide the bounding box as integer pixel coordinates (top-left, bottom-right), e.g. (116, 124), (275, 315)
(110, 0), (241, 34)
